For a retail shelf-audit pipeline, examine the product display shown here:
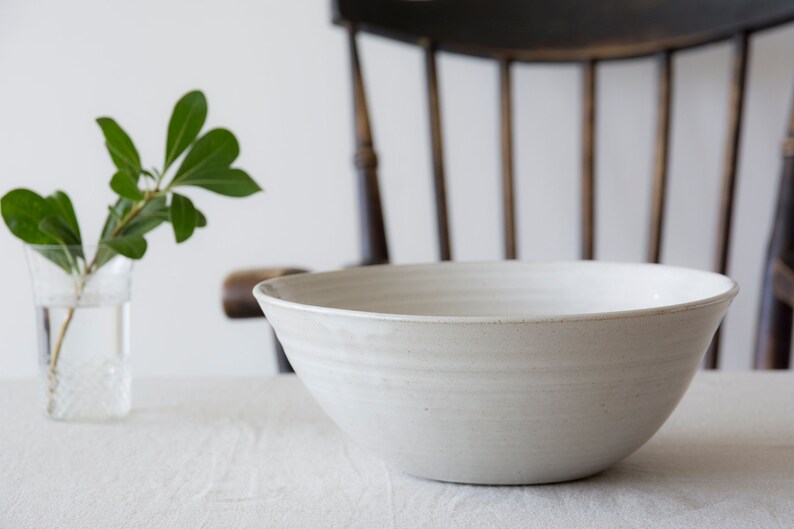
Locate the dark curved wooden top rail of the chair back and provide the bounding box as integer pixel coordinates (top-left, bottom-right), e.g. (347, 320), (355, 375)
(333, 0), (794, 62)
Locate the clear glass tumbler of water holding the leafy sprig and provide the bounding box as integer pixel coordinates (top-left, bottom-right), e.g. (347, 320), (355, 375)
(26, 245), (132, 420)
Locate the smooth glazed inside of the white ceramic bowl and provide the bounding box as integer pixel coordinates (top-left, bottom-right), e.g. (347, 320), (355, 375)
(260, 261), (736, 320)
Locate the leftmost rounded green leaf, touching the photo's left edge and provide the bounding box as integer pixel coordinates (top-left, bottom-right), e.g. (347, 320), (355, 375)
(0, 189), (58, 244)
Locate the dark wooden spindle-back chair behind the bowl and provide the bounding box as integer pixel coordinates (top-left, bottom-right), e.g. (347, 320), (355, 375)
(224, 0), (794, 369)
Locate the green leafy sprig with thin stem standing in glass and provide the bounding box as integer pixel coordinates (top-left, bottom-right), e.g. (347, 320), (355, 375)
(0, 91), (261, 412)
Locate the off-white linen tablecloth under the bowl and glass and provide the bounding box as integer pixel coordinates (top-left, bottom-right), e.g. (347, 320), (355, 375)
(0, 372), (794, 529)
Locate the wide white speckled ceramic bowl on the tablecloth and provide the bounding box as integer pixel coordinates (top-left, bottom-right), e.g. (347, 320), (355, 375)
(254, 261), (738, 484)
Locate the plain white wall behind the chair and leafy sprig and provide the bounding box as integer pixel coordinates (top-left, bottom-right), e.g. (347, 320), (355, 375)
(0, 0), (794, 377)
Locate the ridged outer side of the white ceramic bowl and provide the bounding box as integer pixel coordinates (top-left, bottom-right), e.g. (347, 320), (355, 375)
(255, 264), (736, 484)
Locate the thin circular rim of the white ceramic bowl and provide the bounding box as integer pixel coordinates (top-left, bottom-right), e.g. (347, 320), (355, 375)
(253, 260), (739, 324)
